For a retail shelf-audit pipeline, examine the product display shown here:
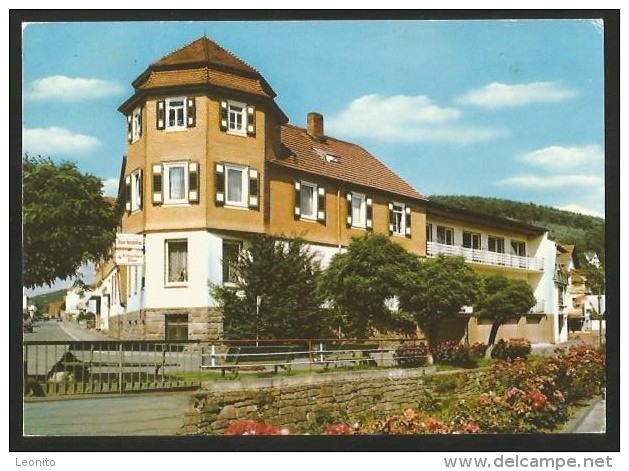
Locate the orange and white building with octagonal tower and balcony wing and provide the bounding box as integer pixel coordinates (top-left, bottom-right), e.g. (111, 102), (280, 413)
(95, 37), (561, 341)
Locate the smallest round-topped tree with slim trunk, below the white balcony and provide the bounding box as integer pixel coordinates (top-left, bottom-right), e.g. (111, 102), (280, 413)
(476, 275), (536, 345)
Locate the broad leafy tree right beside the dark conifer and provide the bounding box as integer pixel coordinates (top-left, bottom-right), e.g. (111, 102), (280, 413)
(319, 234), (419, 338)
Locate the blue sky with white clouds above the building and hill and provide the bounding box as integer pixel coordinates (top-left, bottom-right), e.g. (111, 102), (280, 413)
(22, 15), (605, 292)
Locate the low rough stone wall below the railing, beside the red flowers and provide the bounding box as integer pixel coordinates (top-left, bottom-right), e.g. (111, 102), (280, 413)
(183, 367), (484, 434)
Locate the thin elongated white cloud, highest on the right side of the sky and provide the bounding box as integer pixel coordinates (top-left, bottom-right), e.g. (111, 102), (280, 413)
(459, 82), (577, 109)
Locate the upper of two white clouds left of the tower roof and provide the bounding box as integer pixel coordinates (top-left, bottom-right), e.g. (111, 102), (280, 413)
(25, 75), (125, 101)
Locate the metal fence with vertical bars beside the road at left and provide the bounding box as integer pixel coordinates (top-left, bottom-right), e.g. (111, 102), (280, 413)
(23, 341), (201, 396)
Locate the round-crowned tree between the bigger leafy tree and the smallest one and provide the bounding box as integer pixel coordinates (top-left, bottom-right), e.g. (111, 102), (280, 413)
(400, 255), (479, 351)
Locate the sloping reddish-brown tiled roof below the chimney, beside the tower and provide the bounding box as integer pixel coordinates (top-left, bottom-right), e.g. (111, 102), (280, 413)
(271, 124), (425, 199)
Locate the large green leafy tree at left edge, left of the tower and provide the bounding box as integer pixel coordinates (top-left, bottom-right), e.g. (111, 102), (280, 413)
(22, 155), (118, 288)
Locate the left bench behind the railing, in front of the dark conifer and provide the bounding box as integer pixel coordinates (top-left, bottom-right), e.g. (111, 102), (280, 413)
(201, 345), (301, 376)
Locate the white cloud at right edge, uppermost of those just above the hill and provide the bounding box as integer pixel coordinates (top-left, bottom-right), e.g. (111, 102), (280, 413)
(519, 145), (605, 172)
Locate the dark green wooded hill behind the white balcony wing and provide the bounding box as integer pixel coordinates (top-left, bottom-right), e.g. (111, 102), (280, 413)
(429, 195), (605, 264)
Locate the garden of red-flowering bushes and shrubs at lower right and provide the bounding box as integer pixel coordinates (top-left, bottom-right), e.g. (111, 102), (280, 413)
(220, 339), (606, 435)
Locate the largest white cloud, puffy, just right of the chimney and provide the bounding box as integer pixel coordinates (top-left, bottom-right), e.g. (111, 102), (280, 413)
(326, 94), (507, 143)
